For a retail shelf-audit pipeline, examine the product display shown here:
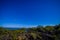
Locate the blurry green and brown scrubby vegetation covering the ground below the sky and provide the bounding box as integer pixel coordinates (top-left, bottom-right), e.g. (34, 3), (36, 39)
(0, 24), (60, 40)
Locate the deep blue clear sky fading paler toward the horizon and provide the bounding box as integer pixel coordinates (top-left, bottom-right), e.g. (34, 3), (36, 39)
(0, 0), (60, 27)
